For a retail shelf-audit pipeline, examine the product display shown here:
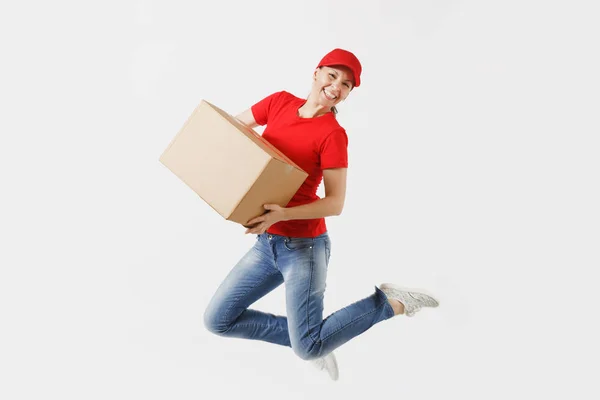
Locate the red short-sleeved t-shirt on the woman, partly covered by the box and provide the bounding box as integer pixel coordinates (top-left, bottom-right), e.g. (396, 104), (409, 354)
(251, 91), (348, 237)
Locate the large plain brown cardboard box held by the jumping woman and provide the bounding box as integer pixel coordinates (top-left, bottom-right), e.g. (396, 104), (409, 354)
(159, 100), (308, 227)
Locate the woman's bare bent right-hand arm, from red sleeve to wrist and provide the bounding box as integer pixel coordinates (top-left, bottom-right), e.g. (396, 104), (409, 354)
(284, 168), (348, 221)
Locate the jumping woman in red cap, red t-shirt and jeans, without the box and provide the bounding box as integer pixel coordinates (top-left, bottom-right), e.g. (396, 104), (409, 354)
(204, 49), (438, 380)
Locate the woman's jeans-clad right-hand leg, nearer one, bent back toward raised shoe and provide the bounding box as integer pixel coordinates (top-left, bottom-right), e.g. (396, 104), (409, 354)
(275, 234), (394, 360)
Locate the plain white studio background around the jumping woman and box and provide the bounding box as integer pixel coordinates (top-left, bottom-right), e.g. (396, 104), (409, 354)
(0, 0), (600, 400)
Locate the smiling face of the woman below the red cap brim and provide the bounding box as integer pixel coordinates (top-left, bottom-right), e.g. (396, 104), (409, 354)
(311, 66), (353, 108)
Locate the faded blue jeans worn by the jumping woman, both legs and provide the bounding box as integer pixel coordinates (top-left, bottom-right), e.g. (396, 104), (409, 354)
(204, 233), (394, 360)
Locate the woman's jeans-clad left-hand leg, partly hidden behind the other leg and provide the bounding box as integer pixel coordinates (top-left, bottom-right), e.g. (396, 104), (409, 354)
(204, 236), (290, 346)
